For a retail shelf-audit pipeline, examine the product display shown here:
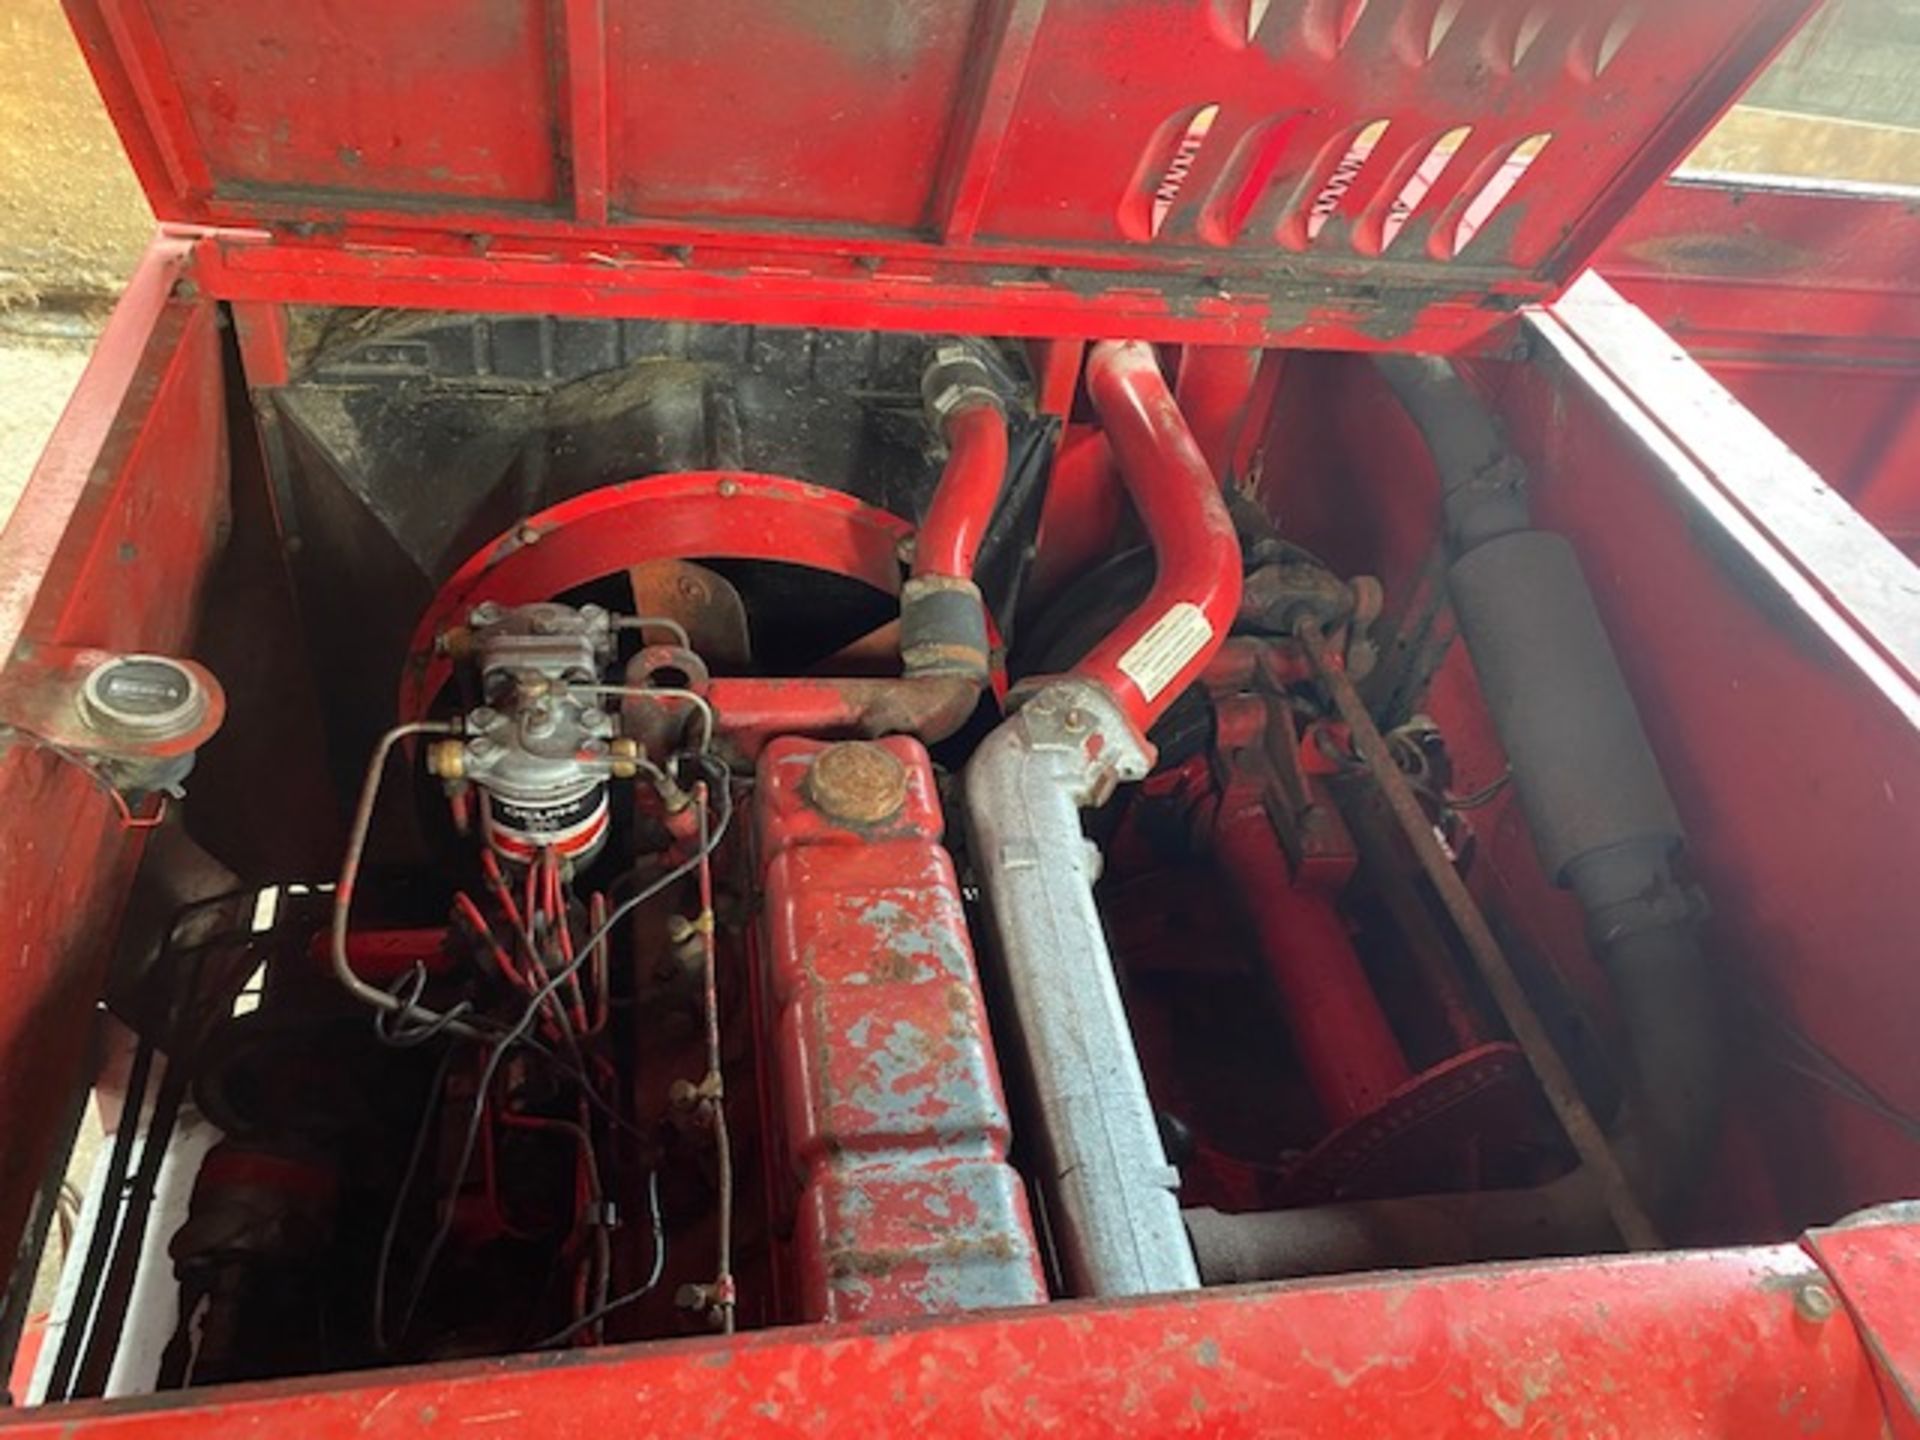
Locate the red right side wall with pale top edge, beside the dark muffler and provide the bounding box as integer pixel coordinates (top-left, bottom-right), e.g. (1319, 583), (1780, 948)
(1488, 278), (1920, 1223)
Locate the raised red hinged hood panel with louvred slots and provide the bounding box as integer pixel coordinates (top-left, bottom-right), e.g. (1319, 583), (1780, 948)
(67, 0), (1816, 342)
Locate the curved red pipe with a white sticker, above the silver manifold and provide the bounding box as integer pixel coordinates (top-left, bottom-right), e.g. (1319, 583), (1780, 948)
(1073, 340), (1240, 733)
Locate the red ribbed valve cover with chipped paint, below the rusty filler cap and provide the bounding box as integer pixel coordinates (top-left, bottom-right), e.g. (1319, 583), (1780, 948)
(756, 737), (1046, 1321)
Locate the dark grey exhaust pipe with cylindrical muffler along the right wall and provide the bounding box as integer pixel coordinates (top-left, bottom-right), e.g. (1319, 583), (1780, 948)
(1379, 355), (1722, 1213)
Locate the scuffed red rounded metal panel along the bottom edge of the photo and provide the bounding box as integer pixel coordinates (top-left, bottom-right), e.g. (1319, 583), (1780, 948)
(0, 1246), (1885, 1440)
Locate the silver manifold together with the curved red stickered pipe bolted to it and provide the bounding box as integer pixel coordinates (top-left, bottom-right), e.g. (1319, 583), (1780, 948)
(966, 342), (1240, 1296)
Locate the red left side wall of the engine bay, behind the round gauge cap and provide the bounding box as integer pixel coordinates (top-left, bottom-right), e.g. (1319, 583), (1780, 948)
(0, 242), (227, 1282)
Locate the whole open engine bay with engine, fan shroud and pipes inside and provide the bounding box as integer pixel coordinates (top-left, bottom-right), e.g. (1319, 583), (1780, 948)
(15, 309), (1896, 1400)
